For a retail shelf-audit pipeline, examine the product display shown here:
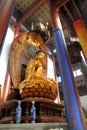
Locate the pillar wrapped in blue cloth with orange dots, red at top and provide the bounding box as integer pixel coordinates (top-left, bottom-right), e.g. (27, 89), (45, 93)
(50, 0), (87, 130)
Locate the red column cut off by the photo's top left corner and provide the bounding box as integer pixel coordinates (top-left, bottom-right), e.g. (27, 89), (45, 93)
(0, 0), (15, 46)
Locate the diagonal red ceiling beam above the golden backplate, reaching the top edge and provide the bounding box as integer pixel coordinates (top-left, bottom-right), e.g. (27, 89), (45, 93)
(18, 0), (46, 24)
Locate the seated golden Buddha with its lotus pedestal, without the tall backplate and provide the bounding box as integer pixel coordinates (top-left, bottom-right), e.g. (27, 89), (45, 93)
(19, 50), (57, 100)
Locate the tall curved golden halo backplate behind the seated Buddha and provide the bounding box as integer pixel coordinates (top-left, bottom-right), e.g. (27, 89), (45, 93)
(9, 32), (47, 88)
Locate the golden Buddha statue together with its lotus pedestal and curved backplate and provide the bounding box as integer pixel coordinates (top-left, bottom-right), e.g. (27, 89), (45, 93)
(9, 32), (58, 101)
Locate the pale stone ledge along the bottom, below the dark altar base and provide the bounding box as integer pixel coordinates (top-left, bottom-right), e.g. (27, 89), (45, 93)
(0, 123), (69, 130)
